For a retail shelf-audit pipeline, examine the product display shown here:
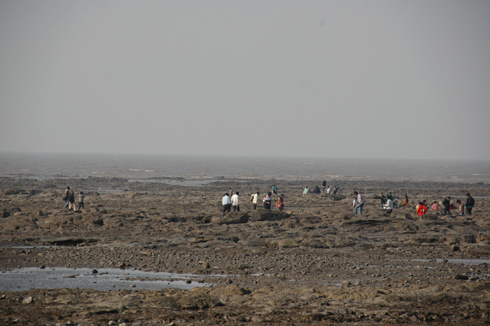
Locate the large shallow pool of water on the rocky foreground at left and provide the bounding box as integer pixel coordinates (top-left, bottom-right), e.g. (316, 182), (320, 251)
(0, 267), (211, 291)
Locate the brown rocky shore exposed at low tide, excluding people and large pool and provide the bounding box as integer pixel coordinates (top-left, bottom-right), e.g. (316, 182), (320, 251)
(0, 178), (490, 325)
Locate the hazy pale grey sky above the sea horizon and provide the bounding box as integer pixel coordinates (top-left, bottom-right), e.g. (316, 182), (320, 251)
(0, 0), (490, 159)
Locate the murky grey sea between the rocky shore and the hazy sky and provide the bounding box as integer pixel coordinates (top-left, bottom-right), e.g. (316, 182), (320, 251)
(0, 152), (490, 184)
